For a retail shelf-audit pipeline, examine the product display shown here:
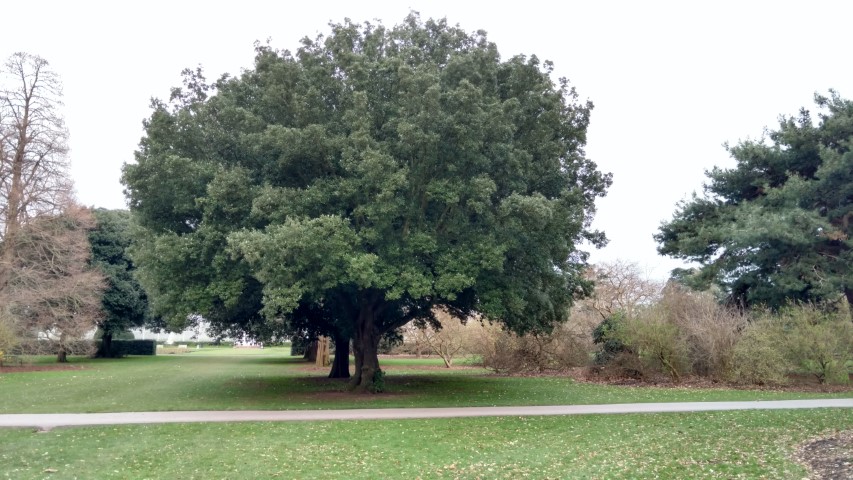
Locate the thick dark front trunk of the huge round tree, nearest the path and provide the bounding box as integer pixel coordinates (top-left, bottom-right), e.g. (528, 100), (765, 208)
(350, 302), (383, 392)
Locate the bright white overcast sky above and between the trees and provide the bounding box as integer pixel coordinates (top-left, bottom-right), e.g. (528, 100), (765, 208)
(0, 0), (853, 278)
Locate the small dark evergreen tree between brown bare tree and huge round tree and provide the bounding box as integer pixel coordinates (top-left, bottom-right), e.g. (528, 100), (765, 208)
(89, 209), (151, 356)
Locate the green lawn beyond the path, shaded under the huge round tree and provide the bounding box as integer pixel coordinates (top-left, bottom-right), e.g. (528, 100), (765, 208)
(0, 348), (853, 413)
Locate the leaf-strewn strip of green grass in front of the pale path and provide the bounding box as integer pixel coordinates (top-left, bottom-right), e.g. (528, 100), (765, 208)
(0, 409), (853, 479)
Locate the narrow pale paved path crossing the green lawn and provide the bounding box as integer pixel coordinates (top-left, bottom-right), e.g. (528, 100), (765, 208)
(0, 398), (853, 431)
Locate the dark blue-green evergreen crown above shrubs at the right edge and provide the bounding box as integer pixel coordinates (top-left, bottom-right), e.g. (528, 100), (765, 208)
(655, 91), (853, 308)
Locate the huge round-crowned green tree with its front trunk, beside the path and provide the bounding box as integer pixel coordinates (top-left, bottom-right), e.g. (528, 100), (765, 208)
(123, 14), (610, 389)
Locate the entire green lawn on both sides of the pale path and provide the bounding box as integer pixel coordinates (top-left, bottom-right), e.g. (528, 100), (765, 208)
(0, 348), (853, 479)
